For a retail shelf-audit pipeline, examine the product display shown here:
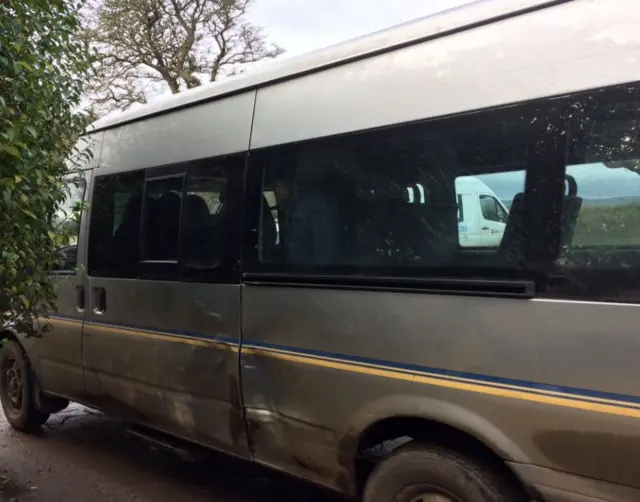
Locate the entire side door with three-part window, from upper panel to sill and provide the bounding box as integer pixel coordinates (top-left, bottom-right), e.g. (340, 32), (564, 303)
(82, 92), (255, 456)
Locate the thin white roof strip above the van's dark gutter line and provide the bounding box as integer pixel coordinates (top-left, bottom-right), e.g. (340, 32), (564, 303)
(88, 0), (573, 132)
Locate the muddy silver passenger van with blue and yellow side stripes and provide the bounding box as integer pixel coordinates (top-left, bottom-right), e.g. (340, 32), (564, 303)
(7, 0), (640, 502)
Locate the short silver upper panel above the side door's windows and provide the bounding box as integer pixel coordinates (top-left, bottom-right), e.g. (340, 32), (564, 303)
(100, 92), (255, 174)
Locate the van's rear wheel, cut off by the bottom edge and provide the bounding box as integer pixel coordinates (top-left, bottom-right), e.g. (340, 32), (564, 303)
(363, 443), (530, 502)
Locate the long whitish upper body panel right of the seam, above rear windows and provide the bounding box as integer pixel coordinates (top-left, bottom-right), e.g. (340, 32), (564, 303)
(251, 0), (640, 148)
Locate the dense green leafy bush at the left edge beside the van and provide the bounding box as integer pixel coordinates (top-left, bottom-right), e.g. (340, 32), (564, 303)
(0, 0), (92, 331)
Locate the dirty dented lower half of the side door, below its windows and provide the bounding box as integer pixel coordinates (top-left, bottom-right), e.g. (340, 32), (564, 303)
(83, 278), (246, 455)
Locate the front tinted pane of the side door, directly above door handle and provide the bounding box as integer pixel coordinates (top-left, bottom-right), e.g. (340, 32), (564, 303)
(88, 171), (144, 278)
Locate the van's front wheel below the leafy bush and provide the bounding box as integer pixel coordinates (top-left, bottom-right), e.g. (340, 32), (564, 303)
(0, 340), (49, 432)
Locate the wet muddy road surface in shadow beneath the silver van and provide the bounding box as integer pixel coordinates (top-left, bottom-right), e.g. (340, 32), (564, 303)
(0, 406), (341, 502)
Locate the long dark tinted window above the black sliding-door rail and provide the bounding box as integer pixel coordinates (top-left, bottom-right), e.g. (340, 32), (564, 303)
(254, 106), (536, 270)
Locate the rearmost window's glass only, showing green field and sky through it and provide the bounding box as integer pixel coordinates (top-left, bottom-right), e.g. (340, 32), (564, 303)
(560, 90), (640, 268)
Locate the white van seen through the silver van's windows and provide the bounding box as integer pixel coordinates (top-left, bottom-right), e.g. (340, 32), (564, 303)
(456, 176), (509, 247)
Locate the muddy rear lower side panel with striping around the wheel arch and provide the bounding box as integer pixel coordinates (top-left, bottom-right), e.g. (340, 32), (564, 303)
(243, 286), (640, 487)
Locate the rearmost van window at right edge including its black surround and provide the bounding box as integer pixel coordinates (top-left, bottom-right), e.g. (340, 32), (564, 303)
(542, 85), (640, 302)
